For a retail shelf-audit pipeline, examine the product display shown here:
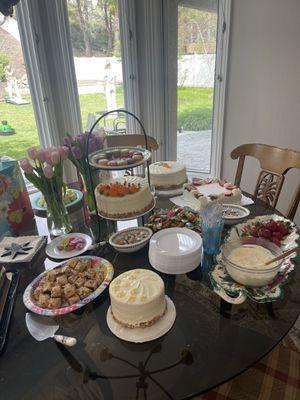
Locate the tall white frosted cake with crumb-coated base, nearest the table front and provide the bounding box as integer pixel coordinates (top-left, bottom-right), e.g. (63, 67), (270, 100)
(109, 269), (167, 328)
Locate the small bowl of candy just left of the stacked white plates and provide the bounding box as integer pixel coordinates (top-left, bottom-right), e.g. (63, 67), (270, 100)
(109, 226), (152, 253)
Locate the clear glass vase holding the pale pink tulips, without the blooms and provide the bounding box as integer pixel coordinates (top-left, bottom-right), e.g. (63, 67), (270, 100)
(44, 192), (72, 236)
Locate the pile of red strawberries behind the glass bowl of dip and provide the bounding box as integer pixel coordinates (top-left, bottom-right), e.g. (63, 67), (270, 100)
(242, 219), (292, 247)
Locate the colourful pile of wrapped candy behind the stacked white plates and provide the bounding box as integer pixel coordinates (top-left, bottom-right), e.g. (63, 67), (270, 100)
(145, 207), (201, 233)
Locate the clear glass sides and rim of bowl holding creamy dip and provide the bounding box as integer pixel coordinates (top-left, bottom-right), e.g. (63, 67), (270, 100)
(221, 237), (282, 287)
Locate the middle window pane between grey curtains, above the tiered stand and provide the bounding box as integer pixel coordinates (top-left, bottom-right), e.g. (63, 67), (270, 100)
(68, 0), (124, 131)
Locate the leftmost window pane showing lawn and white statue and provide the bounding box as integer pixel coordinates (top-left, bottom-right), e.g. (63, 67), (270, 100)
(0, 14), (39, 159)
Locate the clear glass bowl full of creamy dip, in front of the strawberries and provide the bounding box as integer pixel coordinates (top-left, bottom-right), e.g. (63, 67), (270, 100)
(221, 238), (282, 287)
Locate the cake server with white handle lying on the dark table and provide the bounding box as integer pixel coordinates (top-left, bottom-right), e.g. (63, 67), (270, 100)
(25, 313), (77, 347)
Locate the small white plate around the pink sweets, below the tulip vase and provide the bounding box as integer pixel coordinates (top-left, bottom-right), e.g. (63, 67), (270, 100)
(46, 233), (93, 260)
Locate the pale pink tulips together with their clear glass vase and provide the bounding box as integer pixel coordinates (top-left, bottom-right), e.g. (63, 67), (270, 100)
(20, 146), (72, 236)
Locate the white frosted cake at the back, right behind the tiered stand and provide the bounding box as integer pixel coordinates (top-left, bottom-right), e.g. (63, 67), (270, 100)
(149, 161), (187, 190)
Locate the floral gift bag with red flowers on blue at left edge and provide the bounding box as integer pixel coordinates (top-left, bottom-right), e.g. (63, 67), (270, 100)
(0, 160), (34, 238)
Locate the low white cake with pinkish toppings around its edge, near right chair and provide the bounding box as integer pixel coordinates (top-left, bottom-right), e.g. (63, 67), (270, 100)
(183, 178), (242, 210)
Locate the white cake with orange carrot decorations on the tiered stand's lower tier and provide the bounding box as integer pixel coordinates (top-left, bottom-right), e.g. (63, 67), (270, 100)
(95, 176), (154, 218)
